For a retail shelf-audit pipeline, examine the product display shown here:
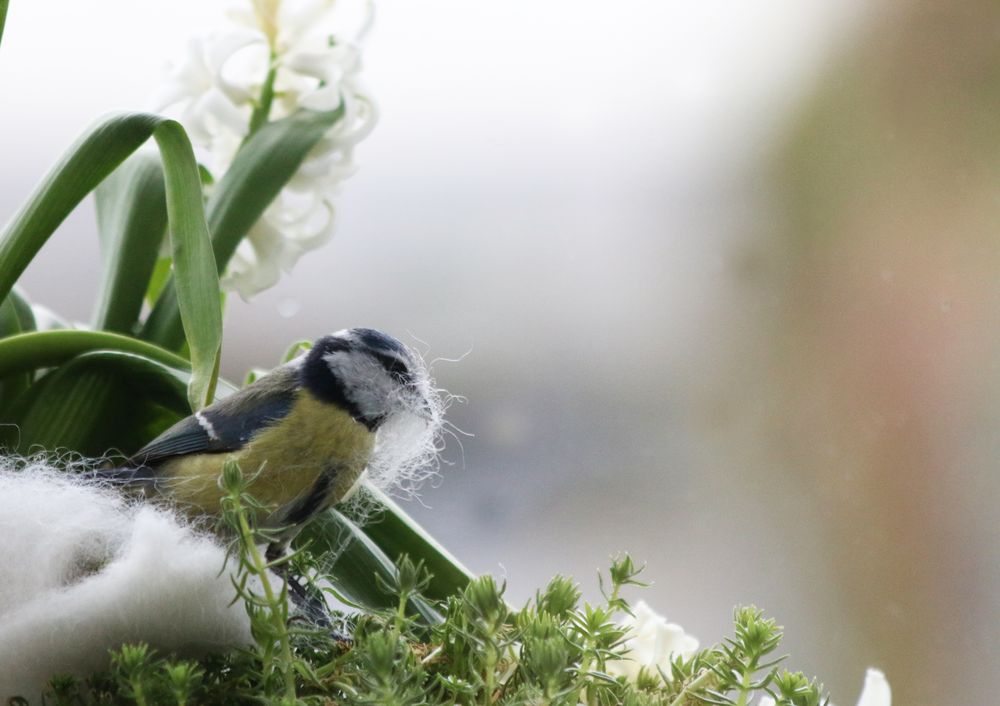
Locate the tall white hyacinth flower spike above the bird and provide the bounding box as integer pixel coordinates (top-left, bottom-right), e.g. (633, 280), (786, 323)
(154, 0), (376, 299)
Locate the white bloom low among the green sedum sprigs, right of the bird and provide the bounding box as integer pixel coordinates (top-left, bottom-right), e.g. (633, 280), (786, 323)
(607, 601), (698, 682)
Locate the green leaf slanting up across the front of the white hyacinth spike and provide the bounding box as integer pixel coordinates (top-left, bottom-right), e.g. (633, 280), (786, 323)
(142, 106), (344, 350)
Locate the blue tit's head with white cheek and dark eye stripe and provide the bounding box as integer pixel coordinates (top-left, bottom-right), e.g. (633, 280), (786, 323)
(302, 328), (433, 431)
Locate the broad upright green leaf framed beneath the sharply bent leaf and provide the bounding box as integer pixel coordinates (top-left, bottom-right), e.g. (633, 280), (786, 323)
(93, 152), (167, 333)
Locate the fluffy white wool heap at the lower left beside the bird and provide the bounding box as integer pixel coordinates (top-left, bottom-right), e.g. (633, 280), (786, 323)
(0, 457), (252, 701)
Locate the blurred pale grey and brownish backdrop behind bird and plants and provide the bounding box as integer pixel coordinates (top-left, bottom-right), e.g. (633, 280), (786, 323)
(0, 0), (1000, 705)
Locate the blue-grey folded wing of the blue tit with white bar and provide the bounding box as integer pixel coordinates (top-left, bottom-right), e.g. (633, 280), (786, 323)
(128, 365), (299, 468)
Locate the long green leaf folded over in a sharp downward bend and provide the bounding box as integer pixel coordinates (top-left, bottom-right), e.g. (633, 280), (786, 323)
(0, 113), (222, 409)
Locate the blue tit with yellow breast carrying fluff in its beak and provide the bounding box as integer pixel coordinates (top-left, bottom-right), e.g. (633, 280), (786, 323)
(118, 328), (430, 530)
